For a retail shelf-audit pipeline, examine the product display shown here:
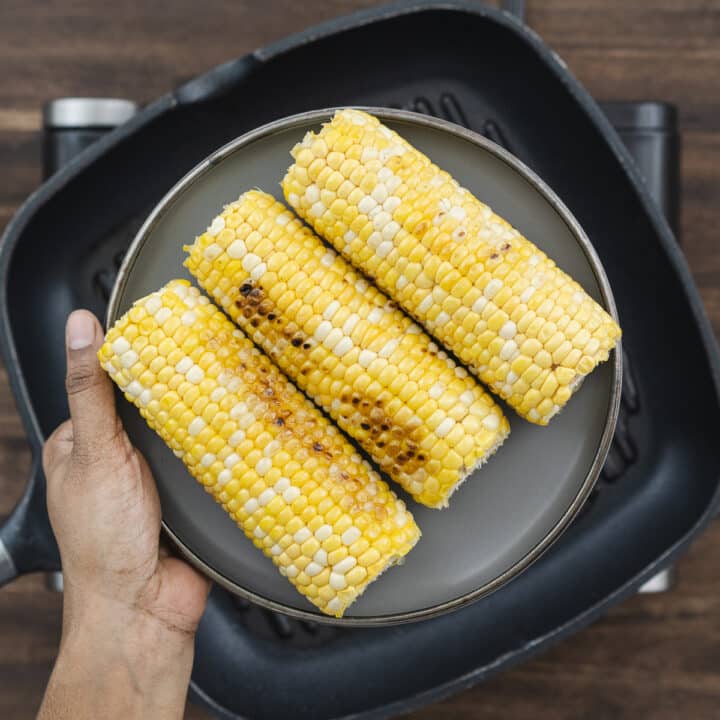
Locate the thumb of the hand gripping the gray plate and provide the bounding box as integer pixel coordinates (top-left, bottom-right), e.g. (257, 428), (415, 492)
(65, 310), (120, 457)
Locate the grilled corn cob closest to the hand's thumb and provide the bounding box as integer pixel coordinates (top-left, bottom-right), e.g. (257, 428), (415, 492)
(99, 280), (420, 617)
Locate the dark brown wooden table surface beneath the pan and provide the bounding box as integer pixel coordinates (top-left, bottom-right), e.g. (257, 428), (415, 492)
(0, 0), (720, 720)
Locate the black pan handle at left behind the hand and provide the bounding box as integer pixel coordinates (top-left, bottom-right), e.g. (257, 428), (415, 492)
(0, 452), (60, 586)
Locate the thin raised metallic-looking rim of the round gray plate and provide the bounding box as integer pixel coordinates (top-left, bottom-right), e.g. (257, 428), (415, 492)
(105, 105), (623, 627)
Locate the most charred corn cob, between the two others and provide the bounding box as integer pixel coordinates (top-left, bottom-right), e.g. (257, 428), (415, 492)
(185, 191), (509, 507)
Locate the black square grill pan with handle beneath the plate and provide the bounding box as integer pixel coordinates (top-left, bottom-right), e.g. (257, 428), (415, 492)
(0, 1), (720, 720)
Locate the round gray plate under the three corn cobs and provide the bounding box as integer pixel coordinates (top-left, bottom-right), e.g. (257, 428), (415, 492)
(108, 108), (621, 624)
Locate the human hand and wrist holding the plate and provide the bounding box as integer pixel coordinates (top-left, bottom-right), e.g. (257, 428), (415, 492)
(40, 310), (209, 718)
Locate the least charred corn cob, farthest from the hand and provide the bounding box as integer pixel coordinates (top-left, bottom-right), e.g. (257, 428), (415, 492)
(283, 110), (620, 425)
